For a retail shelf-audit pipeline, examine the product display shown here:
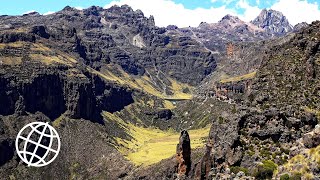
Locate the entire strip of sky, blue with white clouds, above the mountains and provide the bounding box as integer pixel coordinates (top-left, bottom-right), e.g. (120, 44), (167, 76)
(0, 0), (320, 26)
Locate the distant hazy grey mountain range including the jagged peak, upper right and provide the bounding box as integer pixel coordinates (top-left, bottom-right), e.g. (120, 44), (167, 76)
(171, 9), (308, 53)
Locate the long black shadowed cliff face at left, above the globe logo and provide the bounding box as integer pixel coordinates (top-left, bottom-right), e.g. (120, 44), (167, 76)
(0, 64), (133, 123)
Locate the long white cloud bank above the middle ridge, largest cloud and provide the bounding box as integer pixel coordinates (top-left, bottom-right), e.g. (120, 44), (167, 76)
(104, 0), (236, 27)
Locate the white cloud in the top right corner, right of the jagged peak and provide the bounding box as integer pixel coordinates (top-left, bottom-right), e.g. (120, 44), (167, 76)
(271, 0), (320, 25)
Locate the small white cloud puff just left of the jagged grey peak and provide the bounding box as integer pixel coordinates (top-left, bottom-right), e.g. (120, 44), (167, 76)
(237, 0), (261, 22)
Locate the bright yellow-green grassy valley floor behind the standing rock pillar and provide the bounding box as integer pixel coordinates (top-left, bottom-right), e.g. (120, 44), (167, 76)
(103, 112), (210, 166)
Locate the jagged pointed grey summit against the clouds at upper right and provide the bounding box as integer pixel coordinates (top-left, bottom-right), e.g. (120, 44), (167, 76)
(251, 9), (292, 36)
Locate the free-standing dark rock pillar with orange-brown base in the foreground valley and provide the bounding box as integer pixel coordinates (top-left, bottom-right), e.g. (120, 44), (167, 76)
(176, 130), (191, 177)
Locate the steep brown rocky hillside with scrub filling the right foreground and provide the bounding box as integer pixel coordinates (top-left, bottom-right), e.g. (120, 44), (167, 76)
(189, 21), (320, 179)
